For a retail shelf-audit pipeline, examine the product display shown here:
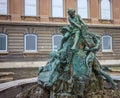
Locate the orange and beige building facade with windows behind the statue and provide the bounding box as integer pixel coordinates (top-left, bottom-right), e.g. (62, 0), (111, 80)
(0, 0), (120, 68)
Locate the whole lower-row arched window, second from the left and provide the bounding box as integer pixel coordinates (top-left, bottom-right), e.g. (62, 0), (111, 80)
(24, 34), (37, 52)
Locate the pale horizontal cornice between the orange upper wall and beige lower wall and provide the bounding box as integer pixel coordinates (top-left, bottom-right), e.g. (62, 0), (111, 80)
(0, 21), (120, 29)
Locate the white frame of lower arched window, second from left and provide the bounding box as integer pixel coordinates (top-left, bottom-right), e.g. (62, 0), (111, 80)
(24, 34), (38, 52)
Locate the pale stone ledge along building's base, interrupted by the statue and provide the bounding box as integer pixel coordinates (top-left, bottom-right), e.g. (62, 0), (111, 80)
(0, 60), (120, 68)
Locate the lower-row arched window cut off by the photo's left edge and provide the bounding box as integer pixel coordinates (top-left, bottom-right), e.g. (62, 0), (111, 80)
(0, 34), (7, 52)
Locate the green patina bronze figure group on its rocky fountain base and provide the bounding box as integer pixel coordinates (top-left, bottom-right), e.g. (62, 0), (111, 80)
(38, 9), (116, 98)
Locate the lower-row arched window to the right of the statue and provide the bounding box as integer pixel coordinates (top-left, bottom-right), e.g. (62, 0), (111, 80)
(102, 35), (112, 52)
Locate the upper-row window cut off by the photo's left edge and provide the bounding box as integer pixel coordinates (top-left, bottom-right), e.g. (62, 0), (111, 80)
(0, 0), (8, 15)
